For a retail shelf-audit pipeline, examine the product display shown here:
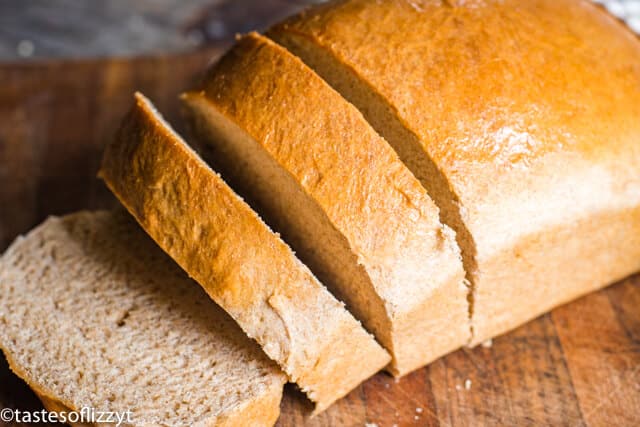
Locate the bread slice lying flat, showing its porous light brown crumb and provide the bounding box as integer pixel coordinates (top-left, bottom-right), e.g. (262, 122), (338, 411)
(0, 211), (286, 426)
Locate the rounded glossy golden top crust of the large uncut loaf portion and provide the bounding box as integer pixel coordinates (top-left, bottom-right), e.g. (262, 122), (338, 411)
(273, 0), (640, 254)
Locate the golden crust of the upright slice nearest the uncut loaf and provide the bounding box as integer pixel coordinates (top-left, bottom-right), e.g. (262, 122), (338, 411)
(185, 33), (469, 375)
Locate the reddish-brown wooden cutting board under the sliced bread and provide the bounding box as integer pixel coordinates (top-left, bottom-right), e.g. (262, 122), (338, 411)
(0, 44), (640, 427)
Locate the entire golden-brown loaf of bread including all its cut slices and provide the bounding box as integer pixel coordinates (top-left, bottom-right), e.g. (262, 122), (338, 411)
(0, 0), (640, 426)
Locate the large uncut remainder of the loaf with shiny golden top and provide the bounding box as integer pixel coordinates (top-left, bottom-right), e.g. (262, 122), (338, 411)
(268, 0), (640, 343)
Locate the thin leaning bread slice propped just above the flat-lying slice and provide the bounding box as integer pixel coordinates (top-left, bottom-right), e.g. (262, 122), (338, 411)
(100, 94), (390, 412)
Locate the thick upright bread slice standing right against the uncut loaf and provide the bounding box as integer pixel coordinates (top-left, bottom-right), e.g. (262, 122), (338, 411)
(183, 33), (470, 375)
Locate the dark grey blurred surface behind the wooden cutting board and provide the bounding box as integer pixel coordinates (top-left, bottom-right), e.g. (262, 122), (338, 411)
(0, 0), (318, 61)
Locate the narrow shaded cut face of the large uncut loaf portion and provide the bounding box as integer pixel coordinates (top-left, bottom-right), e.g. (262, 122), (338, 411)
(267, 31), (477, 342)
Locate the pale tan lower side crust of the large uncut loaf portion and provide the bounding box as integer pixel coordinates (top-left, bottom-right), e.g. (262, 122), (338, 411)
(475, 206), (640, 344)
